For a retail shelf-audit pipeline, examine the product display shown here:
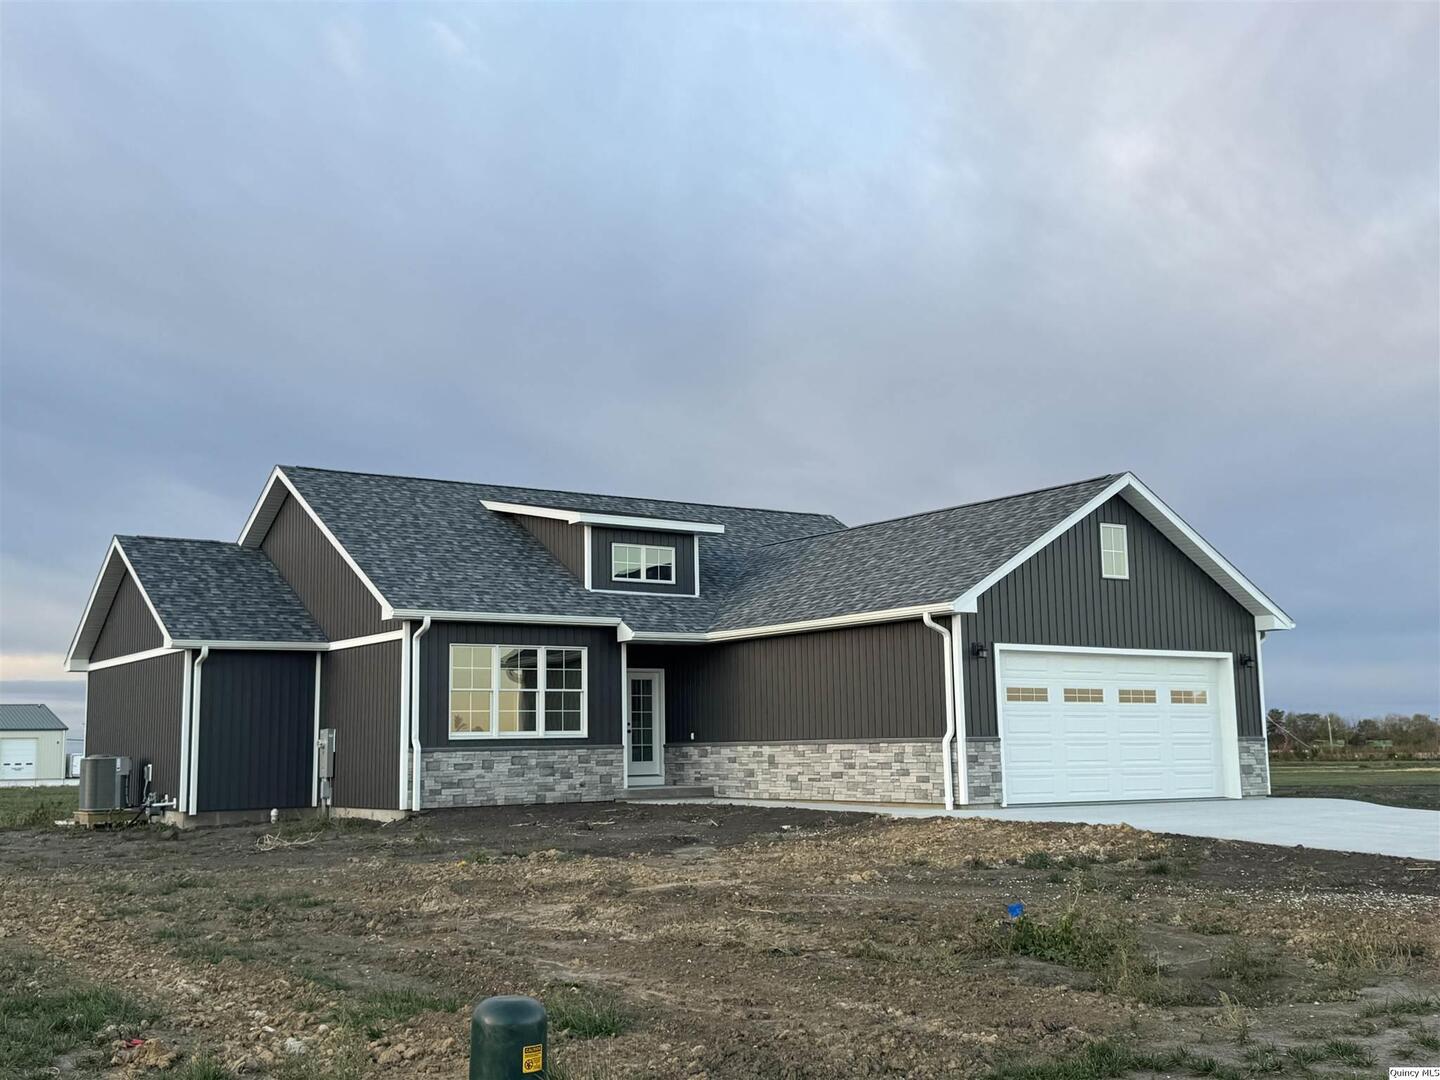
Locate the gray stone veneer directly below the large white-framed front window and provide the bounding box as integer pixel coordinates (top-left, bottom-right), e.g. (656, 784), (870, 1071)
(420, 746), (621, 809)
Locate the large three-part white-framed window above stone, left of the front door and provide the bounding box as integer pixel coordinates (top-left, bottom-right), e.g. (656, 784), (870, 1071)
(449, 645), (589, 739)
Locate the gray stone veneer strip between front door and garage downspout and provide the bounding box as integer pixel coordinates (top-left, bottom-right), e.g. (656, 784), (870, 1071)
(665, 739), (945, 805)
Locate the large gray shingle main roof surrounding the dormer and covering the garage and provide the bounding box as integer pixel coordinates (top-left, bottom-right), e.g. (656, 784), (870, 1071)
(284, 467), (1116, 634)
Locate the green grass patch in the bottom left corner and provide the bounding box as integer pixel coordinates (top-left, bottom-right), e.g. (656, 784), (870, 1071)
(0, 955), (154, 1077)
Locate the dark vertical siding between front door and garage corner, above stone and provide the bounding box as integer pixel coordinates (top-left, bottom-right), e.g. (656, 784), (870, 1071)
(629, 619), (945, 743)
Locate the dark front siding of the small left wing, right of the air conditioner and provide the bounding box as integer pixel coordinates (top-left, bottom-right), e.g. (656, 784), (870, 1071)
(196, 651), (315, 811)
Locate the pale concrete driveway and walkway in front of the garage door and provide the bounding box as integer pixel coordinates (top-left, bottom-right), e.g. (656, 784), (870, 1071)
(656, 799), (1440, 860)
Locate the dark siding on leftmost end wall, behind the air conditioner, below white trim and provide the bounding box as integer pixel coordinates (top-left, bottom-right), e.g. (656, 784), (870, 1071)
(85, 652), (186, 802)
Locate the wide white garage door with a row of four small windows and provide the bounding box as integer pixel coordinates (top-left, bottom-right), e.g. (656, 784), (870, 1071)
(995, 649), (1228, 804)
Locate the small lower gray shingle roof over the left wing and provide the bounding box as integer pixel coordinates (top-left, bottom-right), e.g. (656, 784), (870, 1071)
(115, 536), (325, 642)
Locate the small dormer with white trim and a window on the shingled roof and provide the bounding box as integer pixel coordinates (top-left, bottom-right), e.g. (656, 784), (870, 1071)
(482, 500), (724, 596)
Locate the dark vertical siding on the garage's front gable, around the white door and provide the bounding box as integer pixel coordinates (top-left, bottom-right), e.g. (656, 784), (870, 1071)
(962, 495), (1264, 737)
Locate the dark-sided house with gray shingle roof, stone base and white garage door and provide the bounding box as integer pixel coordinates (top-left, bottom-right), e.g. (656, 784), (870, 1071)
(68, 467), (1293, 816)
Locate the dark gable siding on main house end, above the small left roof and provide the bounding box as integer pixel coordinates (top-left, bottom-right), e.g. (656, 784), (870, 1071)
(261, 498), (400, 642)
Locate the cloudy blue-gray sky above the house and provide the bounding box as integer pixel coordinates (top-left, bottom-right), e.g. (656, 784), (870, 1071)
(0, 3), (1440, 723)
